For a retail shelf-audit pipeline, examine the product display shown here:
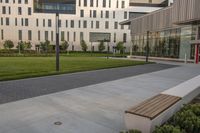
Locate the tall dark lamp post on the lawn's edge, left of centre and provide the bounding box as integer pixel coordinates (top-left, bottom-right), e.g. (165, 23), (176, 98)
(56, 13), (60, 72)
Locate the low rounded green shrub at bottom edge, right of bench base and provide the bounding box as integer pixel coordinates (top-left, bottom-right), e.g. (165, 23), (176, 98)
(153, 125), (183, 133)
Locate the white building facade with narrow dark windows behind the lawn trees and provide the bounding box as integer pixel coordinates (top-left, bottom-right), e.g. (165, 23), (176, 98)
(0, 0), (169, 51)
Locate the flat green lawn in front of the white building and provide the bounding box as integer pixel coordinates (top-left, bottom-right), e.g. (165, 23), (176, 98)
(0, 56), (145, 81)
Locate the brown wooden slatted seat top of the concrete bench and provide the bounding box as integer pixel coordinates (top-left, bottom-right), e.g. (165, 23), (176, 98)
(125, 94), (181, 119)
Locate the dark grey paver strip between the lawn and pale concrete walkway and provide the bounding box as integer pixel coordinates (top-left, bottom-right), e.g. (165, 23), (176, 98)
(0, 64), (176, 104)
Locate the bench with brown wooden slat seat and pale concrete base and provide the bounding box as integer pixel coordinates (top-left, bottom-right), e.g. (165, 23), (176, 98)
(125, 94), (181, 133)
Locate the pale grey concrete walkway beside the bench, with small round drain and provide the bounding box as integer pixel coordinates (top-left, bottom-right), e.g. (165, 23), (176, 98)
(0, 65), (200, 133)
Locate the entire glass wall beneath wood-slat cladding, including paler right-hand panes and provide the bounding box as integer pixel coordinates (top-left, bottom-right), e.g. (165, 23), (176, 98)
(132, 25), (200, 59)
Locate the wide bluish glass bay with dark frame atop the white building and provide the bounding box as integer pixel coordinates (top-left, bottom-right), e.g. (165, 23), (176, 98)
(34, 0), (76, 14)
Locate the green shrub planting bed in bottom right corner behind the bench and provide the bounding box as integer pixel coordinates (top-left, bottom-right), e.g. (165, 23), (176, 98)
(121, 103), (200, 133)
